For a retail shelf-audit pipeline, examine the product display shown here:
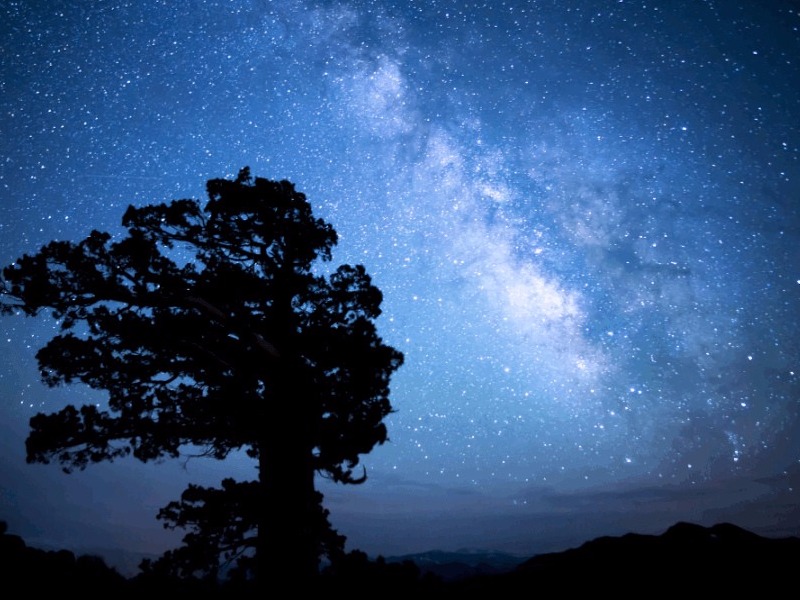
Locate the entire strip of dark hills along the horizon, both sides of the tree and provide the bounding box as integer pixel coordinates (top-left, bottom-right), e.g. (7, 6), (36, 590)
(0, 522), (800, 598)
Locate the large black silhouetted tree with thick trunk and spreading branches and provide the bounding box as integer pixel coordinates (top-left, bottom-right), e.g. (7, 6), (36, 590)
(0, 168), (402, 580)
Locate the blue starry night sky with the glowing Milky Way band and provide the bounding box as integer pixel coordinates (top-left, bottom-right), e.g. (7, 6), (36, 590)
(0, 0), (800, 562)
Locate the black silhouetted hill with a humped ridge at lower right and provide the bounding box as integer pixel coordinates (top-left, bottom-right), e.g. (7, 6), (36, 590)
(450, 523), (800, 595)
